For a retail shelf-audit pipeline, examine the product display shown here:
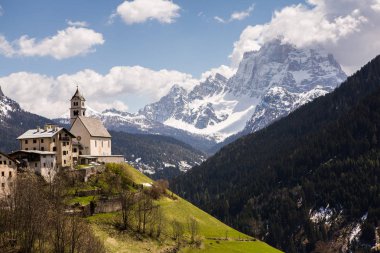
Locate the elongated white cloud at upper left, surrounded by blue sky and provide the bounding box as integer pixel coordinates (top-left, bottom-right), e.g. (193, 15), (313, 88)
(0, 26), (104, 60)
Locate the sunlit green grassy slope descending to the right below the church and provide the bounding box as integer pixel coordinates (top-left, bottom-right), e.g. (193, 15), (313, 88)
(89, 163), (280, 253)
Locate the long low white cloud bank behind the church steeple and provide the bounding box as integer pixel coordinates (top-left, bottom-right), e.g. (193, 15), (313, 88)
(0, 66), (197, 118)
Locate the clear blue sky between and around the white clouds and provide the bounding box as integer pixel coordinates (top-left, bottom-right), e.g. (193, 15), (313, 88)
(0, 0), (297, 77)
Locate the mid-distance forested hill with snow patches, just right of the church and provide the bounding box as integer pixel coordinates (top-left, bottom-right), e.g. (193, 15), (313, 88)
(110, 131), (206, 179)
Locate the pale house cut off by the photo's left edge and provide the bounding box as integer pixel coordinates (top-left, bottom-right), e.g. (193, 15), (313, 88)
(0, 152), (17, 199)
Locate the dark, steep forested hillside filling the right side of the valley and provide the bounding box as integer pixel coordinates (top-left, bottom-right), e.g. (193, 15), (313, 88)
(171, 56), (380, 252)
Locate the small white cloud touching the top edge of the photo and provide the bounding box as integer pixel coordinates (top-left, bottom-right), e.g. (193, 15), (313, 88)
(110, 0), (181, 24)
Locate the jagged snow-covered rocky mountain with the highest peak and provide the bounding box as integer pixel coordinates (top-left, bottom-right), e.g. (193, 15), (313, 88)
(139, 40), (346, 142)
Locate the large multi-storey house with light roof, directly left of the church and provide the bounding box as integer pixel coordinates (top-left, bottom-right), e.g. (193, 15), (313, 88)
(17, 124), (75, 170)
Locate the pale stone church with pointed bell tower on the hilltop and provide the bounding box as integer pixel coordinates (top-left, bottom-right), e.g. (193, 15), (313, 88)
(70, 88), (124, 164)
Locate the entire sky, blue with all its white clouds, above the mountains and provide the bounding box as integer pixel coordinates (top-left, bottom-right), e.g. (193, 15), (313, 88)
(0, 0), (380, 117)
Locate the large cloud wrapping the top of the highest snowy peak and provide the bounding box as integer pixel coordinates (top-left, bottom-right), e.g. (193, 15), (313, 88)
(230, 0), (380, 73)
